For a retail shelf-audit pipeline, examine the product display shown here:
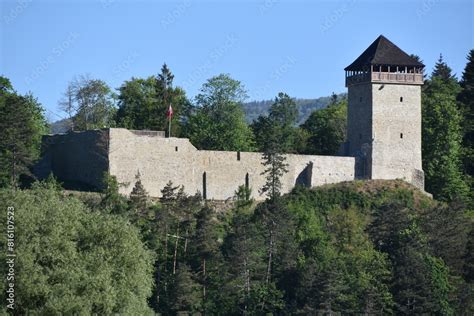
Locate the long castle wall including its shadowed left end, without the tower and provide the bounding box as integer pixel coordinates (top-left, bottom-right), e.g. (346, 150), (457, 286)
(37, 128), (355, 200)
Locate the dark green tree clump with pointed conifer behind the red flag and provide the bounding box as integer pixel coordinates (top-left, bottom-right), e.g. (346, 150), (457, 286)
(116, 64), (190, 136)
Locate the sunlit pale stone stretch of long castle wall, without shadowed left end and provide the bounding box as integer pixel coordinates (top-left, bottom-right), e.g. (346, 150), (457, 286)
(109, 129), (355, 200)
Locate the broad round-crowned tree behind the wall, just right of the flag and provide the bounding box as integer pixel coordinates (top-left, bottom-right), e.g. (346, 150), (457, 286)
(185, 74), (254, 151)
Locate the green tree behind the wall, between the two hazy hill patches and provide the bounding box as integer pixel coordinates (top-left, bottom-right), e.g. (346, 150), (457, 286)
(252, 92), (299, 153)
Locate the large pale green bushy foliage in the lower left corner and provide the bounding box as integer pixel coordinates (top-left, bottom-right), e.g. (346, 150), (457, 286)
(0, 183), (152, 315)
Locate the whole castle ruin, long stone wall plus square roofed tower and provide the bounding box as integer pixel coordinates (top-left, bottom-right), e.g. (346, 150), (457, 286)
(36, 36), (424, 200)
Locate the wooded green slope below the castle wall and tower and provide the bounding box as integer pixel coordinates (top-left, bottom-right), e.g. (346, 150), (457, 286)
(0, 179), (473, 315)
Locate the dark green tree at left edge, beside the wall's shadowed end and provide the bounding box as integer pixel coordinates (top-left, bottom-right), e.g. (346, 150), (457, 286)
(0, 76), (47, 188)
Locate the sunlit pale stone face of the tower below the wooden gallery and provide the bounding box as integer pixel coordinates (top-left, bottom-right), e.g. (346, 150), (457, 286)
(372, 84), (422, 184)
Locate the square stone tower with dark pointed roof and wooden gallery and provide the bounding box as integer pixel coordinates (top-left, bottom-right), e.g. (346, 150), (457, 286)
(344, 35), (424, 189)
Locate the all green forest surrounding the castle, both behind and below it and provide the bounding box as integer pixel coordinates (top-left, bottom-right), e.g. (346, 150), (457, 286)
(0, 50), (474, 315)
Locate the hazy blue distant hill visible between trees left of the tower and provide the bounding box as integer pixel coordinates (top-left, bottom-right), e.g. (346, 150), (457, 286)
(242, 93), (347, 124)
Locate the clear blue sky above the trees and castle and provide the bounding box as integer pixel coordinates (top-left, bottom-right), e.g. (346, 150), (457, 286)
(0, 0), (474, 121)
